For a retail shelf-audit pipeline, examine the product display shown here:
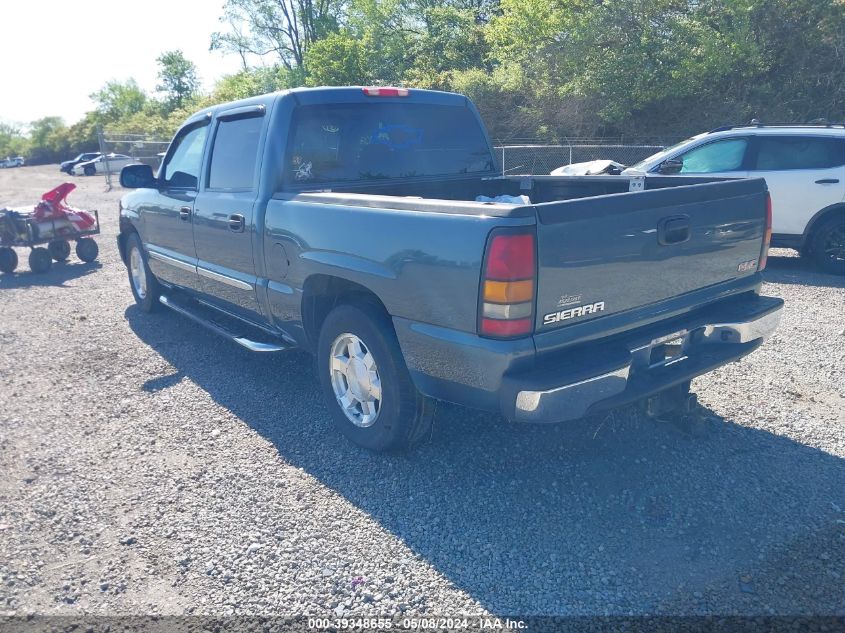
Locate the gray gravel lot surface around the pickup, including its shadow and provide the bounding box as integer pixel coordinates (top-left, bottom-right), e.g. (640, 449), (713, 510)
(0, 167), (845, 615)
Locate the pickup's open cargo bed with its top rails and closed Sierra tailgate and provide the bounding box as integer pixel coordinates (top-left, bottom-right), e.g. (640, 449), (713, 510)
(286, 176), (767, 340)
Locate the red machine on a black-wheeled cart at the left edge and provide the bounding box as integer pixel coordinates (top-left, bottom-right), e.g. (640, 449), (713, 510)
(0, 182), (100, 273)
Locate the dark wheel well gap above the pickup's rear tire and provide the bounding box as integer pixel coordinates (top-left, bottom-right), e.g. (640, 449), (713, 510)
(302, 275), (389, 349)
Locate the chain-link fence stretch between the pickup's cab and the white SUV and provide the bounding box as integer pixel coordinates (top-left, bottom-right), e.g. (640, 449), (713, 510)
(495, 143), (663, 176)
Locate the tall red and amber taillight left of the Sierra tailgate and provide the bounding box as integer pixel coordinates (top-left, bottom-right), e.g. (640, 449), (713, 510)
(479, 231), (537, 338)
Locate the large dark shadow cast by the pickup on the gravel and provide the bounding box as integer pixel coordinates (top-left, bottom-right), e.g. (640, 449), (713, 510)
(126, 306), (845, 614)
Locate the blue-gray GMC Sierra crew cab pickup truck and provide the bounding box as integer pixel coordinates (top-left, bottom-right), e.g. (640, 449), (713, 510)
(118, 88), (783, 450)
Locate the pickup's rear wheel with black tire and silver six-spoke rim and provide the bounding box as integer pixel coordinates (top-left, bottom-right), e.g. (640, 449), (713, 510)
(317, 302), (434, 451)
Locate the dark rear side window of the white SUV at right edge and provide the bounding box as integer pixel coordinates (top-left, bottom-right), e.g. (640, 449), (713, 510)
(756, 136), (845, 171)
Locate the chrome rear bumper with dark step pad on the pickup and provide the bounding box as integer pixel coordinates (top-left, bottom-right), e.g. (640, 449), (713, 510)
(500, 295), (783, 422)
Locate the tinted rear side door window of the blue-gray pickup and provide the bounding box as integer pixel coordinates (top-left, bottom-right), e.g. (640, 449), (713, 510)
(208, 116), (264, 191)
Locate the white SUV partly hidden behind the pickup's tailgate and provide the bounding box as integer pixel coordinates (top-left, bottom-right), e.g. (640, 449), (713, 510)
(622, 124), (845, 274)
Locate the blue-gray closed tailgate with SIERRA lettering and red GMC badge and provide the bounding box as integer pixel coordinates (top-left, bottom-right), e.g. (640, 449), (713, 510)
(535, 178), (767, 334)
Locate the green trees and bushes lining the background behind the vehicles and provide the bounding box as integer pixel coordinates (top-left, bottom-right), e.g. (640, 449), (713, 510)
(13, 0), (845, 161)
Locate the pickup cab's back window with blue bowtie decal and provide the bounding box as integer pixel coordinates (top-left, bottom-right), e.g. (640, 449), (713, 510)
(285, 102), (495, 185)
